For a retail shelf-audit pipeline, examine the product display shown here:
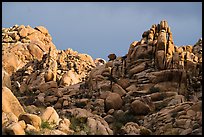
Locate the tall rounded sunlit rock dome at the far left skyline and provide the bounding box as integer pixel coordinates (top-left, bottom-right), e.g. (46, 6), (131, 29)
(2, 25), (56, 75)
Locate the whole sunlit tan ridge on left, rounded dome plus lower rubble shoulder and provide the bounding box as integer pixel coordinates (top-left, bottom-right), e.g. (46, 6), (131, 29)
(2, 25), (95, 92)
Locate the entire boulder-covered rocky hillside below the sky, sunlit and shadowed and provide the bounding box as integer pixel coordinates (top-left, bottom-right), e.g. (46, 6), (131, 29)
(2, 20), (202, 135)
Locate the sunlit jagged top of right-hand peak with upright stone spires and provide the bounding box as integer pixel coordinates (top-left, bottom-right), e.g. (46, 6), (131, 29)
(127, 20), (202, 70)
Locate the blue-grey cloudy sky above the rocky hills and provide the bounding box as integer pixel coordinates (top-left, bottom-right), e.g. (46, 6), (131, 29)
(2, 2), (202, 60)
